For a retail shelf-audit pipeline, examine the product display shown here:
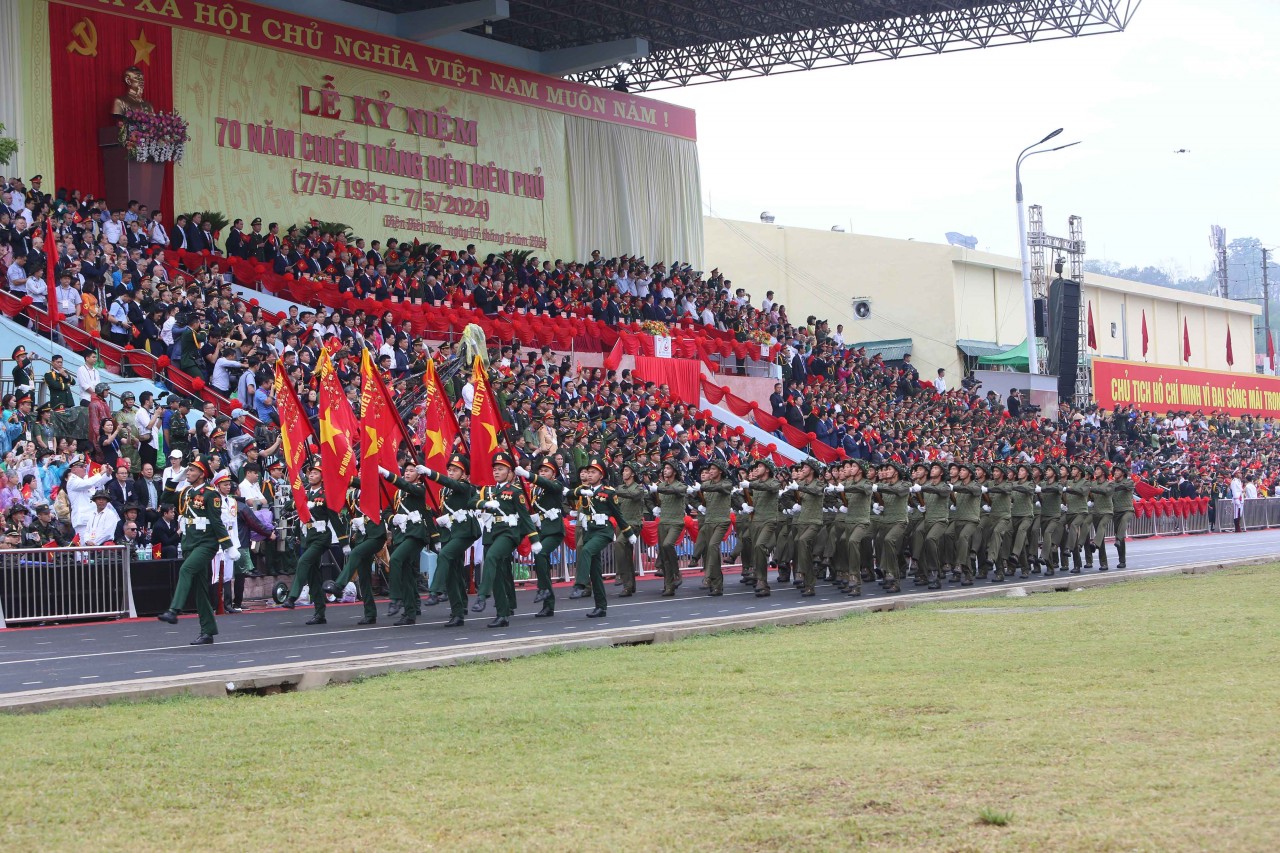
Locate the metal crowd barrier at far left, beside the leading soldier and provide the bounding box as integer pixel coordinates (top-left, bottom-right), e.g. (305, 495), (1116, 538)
(0, 546), (137, 628)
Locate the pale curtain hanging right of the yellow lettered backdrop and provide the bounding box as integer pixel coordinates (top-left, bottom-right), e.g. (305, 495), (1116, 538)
(564, 115), (703, 268)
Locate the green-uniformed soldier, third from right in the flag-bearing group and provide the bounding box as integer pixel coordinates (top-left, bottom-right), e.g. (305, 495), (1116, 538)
(471, 451), (543, 628)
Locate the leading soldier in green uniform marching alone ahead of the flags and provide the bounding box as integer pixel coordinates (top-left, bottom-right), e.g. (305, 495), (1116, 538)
(156, 460), (239, 646)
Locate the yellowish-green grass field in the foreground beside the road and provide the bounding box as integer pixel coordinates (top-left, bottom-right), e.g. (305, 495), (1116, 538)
(0, 566), (1280, 850)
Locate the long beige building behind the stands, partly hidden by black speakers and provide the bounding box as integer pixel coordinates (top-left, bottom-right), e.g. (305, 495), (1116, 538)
(703, 216), (1262, 380)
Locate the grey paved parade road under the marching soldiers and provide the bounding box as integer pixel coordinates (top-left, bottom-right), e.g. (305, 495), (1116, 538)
(0, 530), (1280, 695)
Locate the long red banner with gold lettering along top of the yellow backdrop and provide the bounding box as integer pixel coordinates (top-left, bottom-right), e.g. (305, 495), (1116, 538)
(54, 0), (698, 140)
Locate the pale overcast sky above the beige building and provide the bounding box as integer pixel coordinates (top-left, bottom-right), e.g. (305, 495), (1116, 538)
(654, 0), (1280, 275)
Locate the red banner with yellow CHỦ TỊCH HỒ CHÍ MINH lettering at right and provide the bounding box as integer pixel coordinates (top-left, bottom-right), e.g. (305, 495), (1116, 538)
(1093, 359), (1280, 418)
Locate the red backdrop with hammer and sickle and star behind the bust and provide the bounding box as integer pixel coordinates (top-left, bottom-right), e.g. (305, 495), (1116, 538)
(49, 3), (174, 216)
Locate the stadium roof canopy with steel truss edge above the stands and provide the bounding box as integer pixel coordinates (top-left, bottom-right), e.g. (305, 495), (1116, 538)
(296, 0), (1142, 92)
